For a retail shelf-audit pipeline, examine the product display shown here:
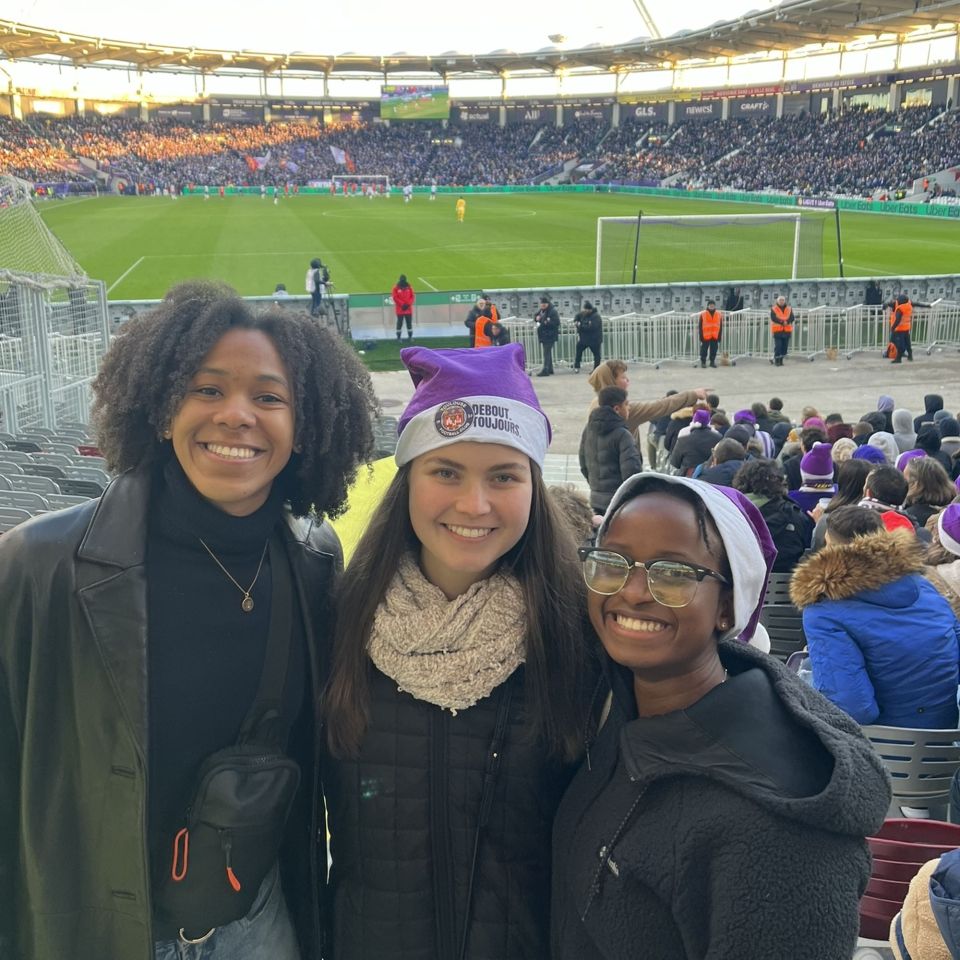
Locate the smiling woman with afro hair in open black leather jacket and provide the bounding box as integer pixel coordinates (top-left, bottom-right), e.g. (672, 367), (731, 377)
(0, 283), (376, 960)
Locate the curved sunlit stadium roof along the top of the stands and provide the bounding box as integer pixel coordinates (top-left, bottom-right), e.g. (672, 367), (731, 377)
(0, 0), (960, 77)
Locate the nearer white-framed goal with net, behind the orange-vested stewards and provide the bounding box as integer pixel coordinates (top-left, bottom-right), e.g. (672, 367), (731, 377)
(596, 213), (824, 284)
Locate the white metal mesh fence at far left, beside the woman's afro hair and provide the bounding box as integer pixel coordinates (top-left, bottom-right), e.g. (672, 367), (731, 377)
(0, 272), (109, 433)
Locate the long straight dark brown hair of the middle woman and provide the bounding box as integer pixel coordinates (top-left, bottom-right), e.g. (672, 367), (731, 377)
(321, 463), (592, 761)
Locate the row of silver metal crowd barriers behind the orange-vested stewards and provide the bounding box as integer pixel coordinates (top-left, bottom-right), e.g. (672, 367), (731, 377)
(503, 300), (960, 370)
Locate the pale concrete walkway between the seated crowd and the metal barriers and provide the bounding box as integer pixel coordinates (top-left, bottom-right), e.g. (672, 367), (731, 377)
(371, 348), (960, 472)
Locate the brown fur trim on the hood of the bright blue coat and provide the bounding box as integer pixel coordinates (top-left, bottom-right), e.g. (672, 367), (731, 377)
(790, 530), (923, 609)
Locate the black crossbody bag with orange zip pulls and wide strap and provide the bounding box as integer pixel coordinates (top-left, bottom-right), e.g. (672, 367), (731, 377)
(153, 538), (300, 938)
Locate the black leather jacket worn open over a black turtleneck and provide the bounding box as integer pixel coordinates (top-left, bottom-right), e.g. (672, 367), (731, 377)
(0, 471), (342, 960)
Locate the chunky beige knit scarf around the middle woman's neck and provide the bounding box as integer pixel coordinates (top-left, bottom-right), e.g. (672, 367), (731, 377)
(368, 555), (526, 714)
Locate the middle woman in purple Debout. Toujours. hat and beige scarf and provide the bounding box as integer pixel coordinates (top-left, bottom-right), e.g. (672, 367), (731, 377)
(324, 343), (596, 960)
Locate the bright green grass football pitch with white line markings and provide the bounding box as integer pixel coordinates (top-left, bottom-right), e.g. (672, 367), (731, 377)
(39, 193), (960, 300)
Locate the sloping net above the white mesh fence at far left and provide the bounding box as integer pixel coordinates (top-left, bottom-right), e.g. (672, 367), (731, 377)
(0, 176), (86, 282)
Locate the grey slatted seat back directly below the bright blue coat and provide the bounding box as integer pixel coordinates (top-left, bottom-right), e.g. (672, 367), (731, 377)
(863, 725), (960, 820)
